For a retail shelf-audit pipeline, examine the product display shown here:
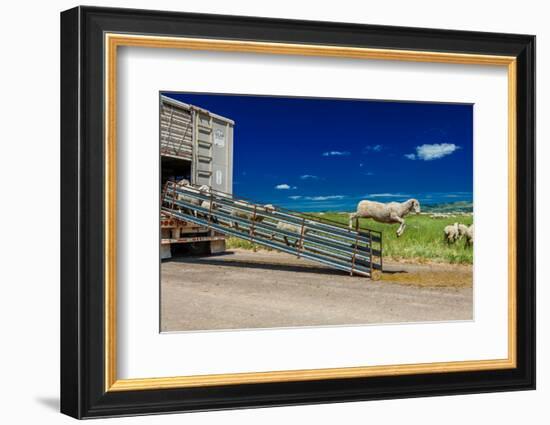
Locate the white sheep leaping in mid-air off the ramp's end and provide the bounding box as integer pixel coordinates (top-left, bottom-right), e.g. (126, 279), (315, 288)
(349, 199), (420, 237)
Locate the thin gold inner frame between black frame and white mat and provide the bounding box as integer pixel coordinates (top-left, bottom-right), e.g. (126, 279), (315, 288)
(104, 33), (517, 391)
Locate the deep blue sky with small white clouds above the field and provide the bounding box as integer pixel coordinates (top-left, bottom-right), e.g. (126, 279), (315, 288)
(163, 93), (473, 211)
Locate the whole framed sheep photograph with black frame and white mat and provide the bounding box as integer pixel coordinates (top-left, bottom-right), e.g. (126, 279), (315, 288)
(61, 7), (535, 418)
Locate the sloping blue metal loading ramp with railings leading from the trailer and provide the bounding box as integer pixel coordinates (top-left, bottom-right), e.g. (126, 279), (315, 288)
(161, 182), (382, 277)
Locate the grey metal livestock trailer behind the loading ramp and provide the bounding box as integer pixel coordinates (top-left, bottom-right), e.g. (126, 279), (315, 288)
(160, 95), (235, 258)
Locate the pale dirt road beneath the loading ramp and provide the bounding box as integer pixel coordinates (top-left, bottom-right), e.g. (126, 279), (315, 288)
(161, 249), (473, 331)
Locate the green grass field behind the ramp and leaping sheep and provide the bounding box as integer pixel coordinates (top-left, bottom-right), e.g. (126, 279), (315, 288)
(228, 213), (473, 264)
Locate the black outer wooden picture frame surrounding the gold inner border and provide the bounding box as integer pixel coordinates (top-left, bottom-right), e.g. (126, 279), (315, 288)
(61, 7), (535, 418)
